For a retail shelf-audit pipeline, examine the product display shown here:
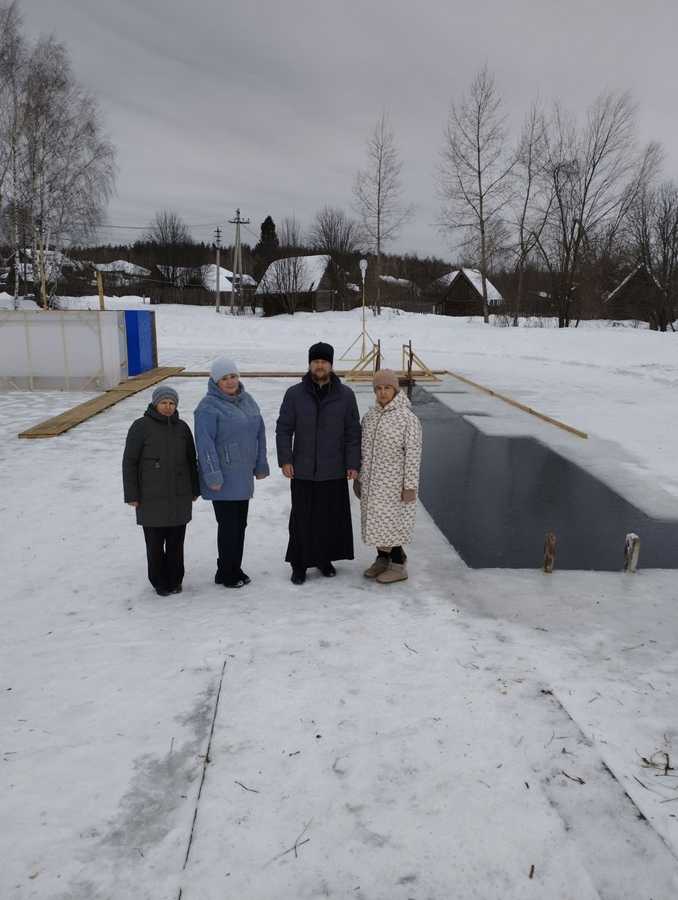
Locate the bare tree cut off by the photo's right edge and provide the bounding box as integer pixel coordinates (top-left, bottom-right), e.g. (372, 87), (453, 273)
(629, 181), (678, 331)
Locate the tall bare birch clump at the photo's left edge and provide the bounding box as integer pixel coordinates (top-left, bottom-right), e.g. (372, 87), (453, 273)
(0, 14), (115, 306)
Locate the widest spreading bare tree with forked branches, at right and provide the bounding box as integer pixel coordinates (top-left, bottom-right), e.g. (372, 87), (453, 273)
(537, 93), (660, 328)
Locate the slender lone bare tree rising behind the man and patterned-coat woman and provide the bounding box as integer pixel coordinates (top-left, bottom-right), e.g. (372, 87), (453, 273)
(353, 113), (414, 313)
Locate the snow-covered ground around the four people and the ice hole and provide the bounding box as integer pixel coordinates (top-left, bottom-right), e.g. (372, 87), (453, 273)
(0, 301), (678, 900)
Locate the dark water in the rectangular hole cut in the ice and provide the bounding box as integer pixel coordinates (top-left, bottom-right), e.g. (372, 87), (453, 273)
(412, 387), (678, 571)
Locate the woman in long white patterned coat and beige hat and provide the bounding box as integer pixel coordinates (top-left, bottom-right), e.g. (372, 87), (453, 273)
(356, 369), (421, 584)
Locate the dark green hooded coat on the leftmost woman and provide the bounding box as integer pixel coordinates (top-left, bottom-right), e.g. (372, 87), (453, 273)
(122, 403), (200, 528)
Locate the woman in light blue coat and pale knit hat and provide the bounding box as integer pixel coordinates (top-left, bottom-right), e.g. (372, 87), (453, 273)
(195, 356), (269, 588)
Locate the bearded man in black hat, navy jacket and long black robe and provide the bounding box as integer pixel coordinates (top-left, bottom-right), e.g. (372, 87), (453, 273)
(275, 343), (360, 584)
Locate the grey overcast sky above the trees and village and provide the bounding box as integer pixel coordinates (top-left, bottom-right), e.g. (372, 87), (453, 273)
(20, 0), (678, 258)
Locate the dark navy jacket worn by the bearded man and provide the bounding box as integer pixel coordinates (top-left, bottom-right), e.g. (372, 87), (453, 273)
(275, 372), (360, 481)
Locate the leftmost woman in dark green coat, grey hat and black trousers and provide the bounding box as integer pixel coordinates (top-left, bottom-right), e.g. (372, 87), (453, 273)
(122, 385), (200, 597)
